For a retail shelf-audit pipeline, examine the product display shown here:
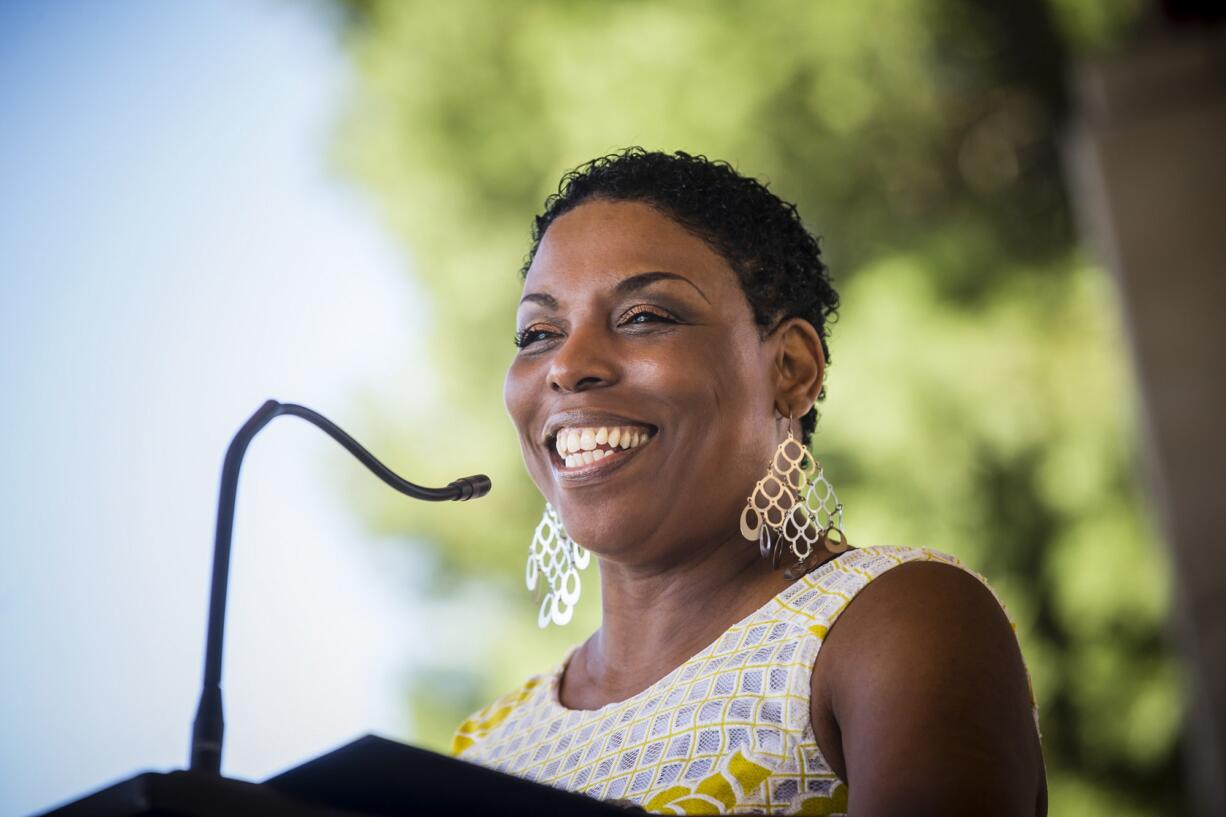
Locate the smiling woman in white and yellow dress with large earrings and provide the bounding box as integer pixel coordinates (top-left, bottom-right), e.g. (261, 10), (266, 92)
(455, 148), (1046, 817)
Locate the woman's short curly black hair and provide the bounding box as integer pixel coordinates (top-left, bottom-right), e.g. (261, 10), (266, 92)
(521, 147), (839, 445)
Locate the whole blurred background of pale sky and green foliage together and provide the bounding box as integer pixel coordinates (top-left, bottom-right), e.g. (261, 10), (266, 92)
(0, 0), (1211, 816)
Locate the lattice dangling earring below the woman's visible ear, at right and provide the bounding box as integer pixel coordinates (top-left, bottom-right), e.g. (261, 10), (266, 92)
(741, 417), (850, 571)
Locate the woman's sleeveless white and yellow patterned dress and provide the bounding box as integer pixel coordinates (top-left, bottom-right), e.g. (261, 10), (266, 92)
(451, 547), (1038, 815)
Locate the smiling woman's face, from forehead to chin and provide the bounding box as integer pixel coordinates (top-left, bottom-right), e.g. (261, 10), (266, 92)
(504, 200), (780, 566)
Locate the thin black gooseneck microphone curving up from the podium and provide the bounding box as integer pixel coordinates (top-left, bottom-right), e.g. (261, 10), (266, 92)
(190, 400), (490, 774)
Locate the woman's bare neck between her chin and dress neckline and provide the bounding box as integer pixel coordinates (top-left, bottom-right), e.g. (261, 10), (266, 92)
(563, 532), (790, 709)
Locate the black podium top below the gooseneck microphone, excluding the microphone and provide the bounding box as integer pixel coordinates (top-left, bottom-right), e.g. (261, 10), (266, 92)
(40, 735), (641, 817)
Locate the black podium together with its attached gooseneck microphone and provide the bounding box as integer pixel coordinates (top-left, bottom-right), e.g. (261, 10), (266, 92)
(33, 400), (626, 817)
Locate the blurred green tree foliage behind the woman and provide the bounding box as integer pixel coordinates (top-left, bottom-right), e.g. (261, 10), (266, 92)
(337, 0), (1182, 815)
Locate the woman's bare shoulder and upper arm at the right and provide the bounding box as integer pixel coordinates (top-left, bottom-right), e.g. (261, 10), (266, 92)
(810, 562), (1046, 817)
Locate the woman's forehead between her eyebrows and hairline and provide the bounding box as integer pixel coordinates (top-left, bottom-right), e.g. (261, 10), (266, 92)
(525, 201), (741, 301)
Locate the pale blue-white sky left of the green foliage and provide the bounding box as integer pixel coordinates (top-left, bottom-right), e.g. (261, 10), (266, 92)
(0, 0), (441, 815)
